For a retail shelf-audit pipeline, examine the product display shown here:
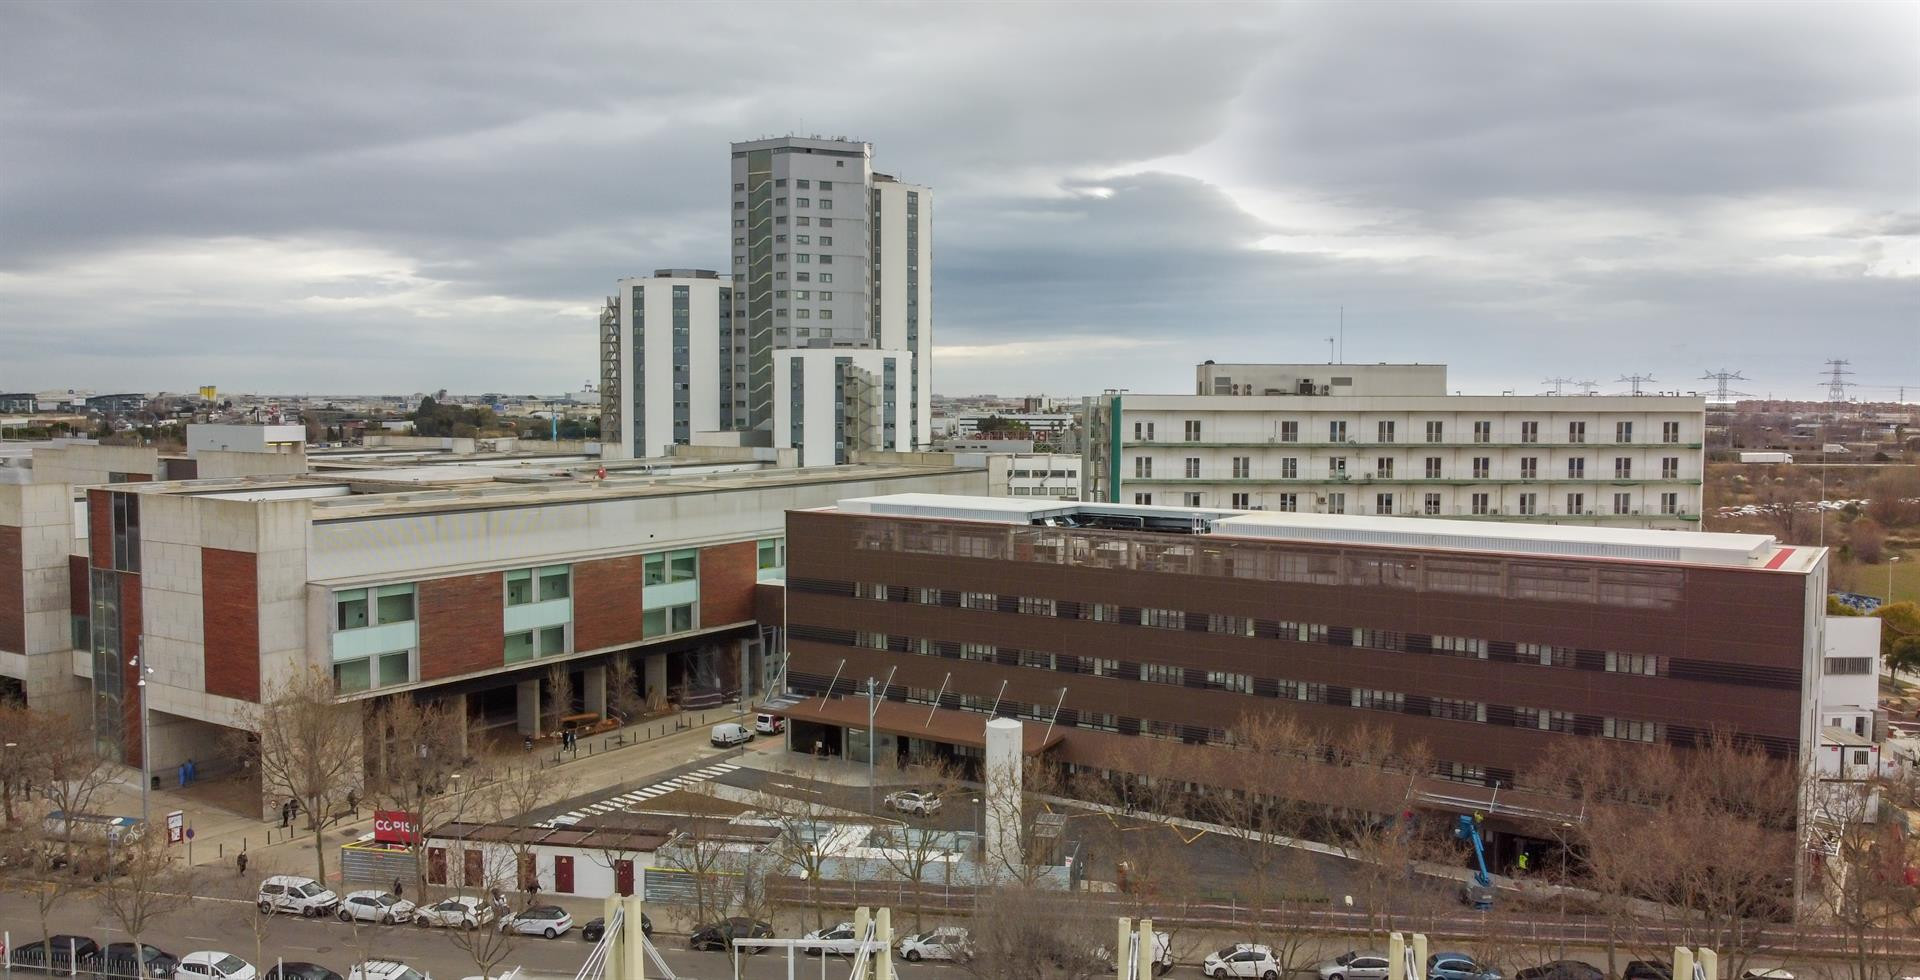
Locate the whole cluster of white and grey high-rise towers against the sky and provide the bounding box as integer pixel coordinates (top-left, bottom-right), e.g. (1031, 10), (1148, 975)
(599, 136), (933, 463)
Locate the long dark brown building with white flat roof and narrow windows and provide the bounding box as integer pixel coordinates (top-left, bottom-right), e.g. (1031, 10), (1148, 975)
(771, 494), (1826, 796)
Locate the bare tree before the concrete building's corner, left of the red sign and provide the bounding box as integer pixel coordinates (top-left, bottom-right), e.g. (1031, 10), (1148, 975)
(234, 669), (363, 882)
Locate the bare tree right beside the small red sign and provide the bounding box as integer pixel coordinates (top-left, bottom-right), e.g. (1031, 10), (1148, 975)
(369, 694), (470, 895)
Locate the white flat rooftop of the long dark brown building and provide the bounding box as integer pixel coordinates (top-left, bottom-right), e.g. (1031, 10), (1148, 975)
(833, 494), (1824, 573)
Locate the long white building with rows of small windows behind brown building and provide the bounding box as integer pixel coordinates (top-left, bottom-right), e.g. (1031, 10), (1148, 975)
(1083, 365), (1705, 530)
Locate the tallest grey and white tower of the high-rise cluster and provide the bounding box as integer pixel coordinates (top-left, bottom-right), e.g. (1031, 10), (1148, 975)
(722, 136), (933, 450)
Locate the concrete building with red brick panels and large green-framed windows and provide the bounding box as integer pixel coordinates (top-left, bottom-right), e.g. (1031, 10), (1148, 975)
(61, 465), (985, 784)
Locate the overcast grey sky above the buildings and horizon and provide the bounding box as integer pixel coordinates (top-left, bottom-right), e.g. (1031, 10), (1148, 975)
(0, 2), (1920, 398)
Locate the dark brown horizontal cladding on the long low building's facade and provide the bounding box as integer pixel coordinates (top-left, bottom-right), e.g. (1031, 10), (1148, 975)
(787, 511), (1807, 784)
